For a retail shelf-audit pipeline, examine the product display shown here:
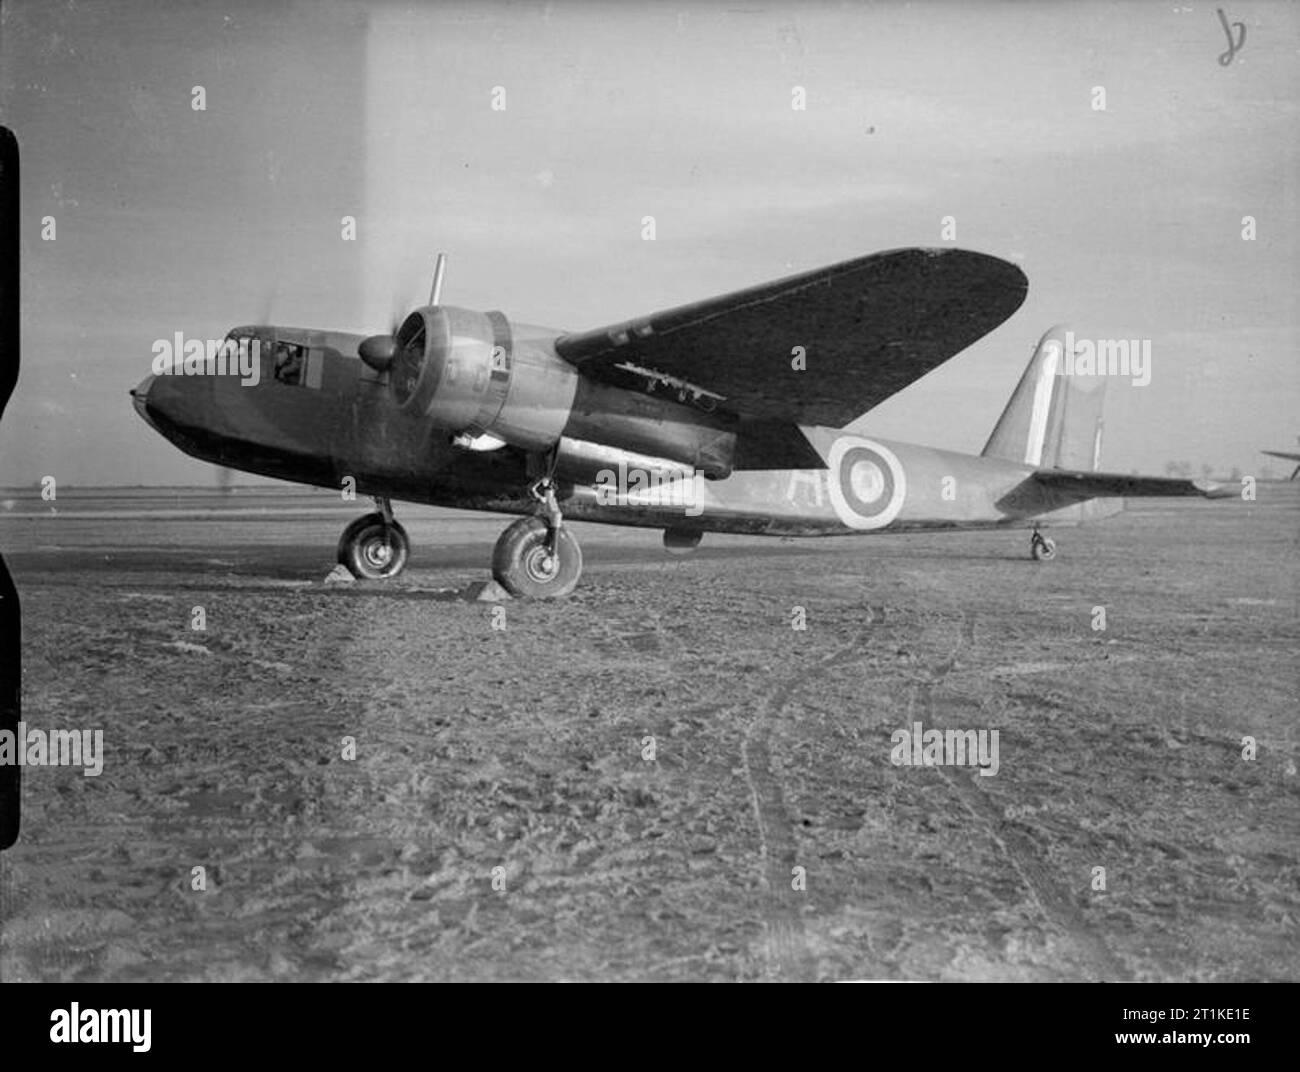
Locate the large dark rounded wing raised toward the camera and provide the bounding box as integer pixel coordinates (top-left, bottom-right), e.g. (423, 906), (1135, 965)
(555, 249), (1028, 428)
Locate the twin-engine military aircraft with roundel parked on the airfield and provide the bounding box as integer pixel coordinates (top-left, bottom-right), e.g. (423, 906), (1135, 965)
(131, 249), (1217, 598)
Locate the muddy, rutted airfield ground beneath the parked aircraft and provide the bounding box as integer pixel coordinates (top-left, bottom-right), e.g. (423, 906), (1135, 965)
(0, 485), (1300, 981)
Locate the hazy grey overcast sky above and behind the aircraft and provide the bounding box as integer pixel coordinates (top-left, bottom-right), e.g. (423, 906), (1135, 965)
(0, 0), (1300, 485)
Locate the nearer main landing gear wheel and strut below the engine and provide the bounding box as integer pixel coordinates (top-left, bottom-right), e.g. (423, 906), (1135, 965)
(491, 465), (582, 599)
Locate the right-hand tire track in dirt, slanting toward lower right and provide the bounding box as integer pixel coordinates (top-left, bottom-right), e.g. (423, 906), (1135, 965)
(909, 609), (1131, 982)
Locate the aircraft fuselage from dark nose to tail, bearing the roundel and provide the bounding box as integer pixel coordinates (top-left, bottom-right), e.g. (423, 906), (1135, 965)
(133, 318), (1114, 535)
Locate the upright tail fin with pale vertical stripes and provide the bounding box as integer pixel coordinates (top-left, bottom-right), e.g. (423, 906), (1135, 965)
(983, 325), (1106, 472)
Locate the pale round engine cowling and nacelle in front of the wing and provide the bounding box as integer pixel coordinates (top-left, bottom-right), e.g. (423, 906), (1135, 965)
(389, 305), (579, 451)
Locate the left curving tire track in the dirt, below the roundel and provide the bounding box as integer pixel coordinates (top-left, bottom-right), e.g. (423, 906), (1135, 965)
(741, 606), (885, 982)
